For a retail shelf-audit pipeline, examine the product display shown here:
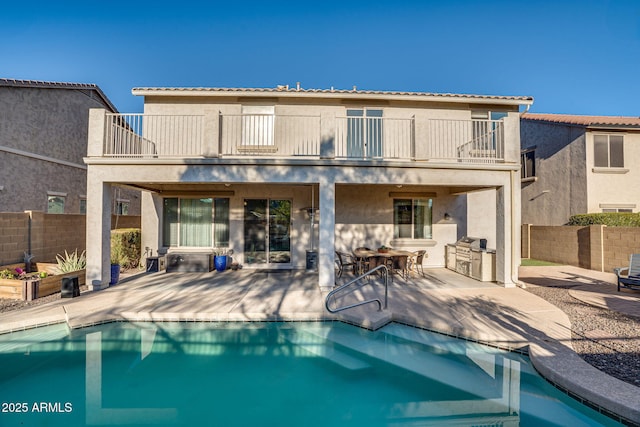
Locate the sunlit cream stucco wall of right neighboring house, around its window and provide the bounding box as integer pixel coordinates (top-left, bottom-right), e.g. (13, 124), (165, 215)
(584, 131), (640, 213)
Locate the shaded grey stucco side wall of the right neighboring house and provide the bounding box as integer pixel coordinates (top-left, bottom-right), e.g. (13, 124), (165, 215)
(520, 119), (587, 225)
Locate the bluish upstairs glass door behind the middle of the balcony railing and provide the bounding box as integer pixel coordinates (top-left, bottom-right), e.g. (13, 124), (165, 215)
(347, 109), (383, 158)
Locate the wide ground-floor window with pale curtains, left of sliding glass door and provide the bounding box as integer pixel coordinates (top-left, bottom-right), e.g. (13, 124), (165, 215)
(162, 198), (229, 247)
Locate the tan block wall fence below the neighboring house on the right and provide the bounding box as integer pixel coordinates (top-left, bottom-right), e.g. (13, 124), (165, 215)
(522, 224), (640, 273)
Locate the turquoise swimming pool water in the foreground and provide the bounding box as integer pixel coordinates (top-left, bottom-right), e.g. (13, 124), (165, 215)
(0, 322), (617, 427)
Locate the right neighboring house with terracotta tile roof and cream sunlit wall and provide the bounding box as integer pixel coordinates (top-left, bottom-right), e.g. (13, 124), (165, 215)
(520, 113), (640, 225)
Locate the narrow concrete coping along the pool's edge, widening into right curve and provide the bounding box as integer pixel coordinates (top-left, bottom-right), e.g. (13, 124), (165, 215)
(0, 307), (640, 426)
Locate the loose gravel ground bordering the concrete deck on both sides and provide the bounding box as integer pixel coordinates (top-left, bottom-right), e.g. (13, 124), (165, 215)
(0, 284), (640, 387)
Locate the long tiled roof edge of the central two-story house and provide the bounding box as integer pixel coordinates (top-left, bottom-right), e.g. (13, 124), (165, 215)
(131, 86), (533, 105)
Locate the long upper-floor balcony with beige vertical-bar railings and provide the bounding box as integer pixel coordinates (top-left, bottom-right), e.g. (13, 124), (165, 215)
(102, 114), (505, 163)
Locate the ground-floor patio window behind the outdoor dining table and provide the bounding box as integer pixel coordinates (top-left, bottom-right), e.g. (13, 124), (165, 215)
(393, 199), (433, 239)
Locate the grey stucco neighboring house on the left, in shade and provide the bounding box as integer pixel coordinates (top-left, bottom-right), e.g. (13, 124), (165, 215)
(0, 79), (140, 214)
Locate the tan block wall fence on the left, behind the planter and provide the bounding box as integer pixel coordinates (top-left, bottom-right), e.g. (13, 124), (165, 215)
(0, 211), (140, 265)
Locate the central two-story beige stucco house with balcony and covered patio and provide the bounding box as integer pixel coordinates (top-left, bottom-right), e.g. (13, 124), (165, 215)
(86, 86), (533, 290)
